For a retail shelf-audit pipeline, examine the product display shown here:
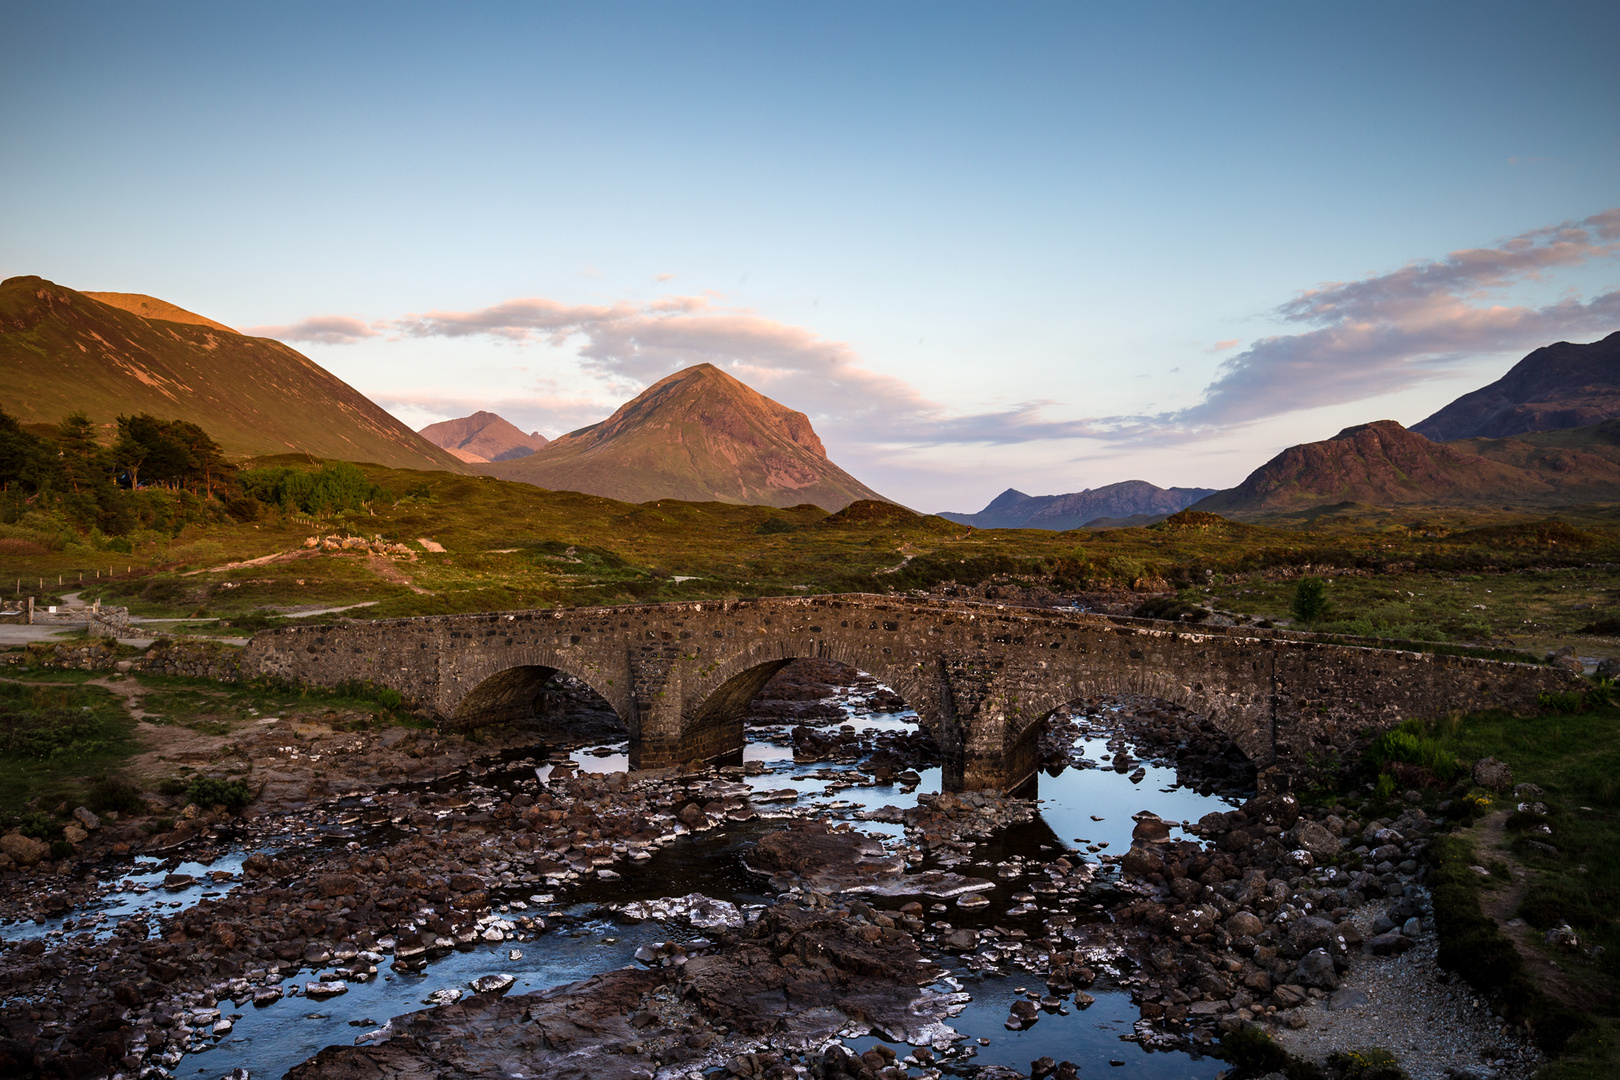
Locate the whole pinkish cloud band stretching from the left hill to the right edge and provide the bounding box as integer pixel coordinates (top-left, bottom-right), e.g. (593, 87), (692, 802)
(249, 209), (1620, 447)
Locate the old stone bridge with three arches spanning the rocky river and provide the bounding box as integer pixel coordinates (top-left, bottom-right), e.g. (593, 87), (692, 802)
(241, 594), (1578, 790)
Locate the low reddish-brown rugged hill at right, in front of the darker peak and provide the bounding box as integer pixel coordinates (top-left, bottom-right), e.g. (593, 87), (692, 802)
(1192, 419), (1620, 513)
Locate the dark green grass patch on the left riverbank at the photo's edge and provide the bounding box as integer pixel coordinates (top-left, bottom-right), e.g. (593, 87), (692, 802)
(0, 680), (134, 834)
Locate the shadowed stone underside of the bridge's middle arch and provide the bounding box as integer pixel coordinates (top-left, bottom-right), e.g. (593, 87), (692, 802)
(680, 643), (961, 777)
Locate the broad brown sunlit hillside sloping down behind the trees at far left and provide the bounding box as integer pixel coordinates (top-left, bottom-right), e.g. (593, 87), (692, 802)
(0, 277), (468, 473)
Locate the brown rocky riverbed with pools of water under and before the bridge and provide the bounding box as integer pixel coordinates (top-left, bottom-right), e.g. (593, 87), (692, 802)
(0, 664), (1534, 1080)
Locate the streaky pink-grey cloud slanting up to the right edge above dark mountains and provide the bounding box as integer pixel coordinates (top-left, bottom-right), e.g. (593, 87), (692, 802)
(1179, 209), (1620, 427)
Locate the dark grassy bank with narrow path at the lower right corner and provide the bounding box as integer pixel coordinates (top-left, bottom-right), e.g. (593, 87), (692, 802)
(1385, 685), (1620, 1080)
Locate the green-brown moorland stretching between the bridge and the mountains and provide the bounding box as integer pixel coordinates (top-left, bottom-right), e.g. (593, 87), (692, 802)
(0, 457), (1620, 656)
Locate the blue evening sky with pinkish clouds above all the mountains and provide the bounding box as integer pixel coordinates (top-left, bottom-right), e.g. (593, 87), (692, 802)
(0, 0), (1620, 512)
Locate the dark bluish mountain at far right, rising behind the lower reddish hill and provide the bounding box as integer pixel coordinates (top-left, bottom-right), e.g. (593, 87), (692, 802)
(1411, 330), (1620, 442)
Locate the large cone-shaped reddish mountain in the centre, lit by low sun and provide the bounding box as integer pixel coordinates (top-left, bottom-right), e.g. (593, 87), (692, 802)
(475, 364), (889, 510)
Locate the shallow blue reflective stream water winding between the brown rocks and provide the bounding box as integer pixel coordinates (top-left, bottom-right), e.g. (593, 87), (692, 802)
(0, 706), (1228, 1080)
